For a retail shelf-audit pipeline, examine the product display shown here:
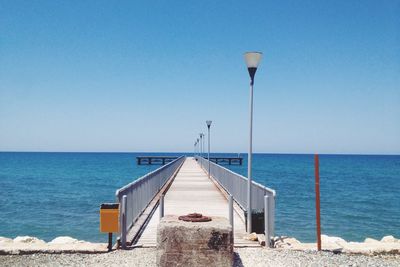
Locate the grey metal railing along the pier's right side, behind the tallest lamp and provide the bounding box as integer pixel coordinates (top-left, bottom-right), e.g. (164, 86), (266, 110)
(196, 156), (276, 243)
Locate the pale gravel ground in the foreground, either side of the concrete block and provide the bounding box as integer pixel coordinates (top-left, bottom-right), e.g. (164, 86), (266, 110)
(0, 248), (400, 267)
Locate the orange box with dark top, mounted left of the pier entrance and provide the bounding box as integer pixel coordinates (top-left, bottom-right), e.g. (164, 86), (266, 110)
(100, 203), (119, 233)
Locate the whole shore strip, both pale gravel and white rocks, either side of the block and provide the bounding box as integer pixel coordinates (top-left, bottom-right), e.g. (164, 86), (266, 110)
(0, 236), (400, 267)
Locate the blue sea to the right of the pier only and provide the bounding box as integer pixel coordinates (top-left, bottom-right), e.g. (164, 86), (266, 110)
(223, 154), (400, 242)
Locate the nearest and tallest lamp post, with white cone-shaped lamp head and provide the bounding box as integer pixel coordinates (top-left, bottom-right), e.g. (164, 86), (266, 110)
(244, 52), (262, 233)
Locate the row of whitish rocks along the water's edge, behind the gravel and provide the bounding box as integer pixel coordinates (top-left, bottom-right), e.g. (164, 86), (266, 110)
(0, 235), (400, 256)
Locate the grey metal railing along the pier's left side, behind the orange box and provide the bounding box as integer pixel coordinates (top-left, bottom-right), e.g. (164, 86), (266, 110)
(115, 156), (185, 246)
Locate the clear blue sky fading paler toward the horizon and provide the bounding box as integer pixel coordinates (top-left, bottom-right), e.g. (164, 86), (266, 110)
(0, 0), (400, 154)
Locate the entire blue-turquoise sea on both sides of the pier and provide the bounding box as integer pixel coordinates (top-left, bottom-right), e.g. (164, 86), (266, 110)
(0, 153), (400, 242)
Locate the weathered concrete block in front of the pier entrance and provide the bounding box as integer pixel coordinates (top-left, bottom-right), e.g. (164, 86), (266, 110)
(157, 215), (233, 267)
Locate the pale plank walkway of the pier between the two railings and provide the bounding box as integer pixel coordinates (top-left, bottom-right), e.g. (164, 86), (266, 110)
(136, 158), (259, 247)
